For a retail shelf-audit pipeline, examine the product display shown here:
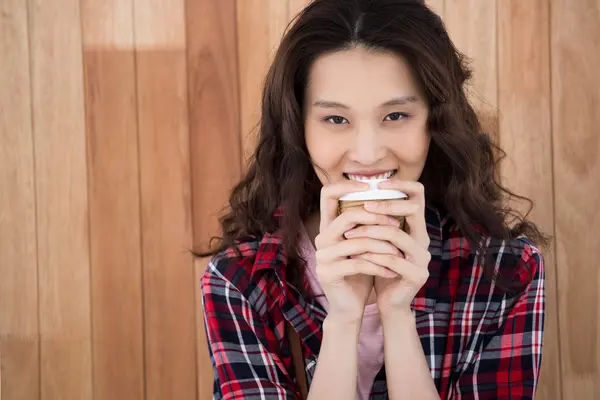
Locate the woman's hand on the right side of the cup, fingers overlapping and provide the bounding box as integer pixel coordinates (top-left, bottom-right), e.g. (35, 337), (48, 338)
(345, 181), (431, 316)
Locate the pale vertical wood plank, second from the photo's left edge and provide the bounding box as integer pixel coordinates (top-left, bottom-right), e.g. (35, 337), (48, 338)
(29, 0), (92, 400)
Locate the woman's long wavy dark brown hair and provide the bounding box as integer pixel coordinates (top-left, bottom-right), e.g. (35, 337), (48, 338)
(194, 0), (548, 294)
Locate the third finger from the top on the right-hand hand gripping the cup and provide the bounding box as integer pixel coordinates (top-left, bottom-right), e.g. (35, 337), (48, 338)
(344, 225), (429, 265)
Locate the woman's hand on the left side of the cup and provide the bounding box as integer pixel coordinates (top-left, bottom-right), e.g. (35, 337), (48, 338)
(315, 181), (400, 323)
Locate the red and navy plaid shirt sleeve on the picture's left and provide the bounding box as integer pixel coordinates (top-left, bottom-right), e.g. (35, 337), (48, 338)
(201, 261), (296, 400)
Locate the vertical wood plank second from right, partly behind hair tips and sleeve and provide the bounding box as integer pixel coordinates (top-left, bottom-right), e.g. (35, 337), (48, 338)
(498, 0), (561, 400)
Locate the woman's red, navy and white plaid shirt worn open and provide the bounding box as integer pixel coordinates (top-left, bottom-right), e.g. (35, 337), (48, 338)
(201, 206), (545, 400)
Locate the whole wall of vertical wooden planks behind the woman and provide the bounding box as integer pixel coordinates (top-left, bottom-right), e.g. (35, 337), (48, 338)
(0, 0), (600, 400)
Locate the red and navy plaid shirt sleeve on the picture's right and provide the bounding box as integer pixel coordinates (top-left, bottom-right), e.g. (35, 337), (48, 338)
(452, 245), (545, 400)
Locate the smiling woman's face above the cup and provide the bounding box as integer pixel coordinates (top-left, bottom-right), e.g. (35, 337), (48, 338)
(304, 47), (430, 185)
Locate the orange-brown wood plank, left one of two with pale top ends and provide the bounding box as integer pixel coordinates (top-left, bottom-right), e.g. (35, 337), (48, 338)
(81, 0), (144, 400)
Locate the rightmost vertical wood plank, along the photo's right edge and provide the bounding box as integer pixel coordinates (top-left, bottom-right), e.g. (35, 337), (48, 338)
(551, 0), (600, 399)
